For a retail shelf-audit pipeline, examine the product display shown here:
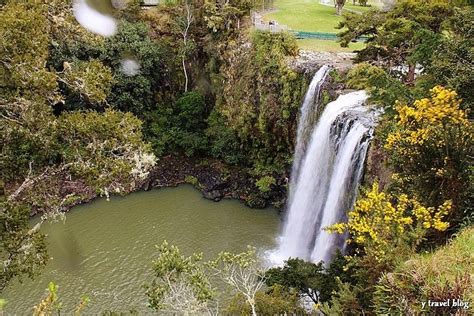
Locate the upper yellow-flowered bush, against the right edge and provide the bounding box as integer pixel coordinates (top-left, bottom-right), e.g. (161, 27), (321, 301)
(384, 86), (474, 227)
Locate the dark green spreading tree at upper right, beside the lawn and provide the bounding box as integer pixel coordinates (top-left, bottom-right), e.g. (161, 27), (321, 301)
(338, 0), (454, 84)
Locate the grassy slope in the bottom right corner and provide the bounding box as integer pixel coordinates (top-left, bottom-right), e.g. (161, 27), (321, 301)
(376, 227), (474, 315)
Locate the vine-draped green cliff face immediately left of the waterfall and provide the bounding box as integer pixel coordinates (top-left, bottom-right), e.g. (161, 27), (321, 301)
(210, 32), (305, 173)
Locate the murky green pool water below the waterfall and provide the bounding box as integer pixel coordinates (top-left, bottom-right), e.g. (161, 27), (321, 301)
(0, 185), (279, 315)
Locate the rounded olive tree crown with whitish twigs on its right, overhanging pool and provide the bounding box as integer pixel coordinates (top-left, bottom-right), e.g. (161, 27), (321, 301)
(58, 110), (155, 195)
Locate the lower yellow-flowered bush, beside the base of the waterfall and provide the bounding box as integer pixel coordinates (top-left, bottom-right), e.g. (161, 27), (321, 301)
(327, 183), (451, 260)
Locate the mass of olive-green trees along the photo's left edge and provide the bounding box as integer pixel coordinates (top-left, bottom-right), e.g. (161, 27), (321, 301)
(0, 0), (155, 289)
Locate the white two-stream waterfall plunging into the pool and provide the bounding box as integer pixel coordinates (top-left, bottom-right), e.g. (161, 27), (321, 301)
(272, 66), (376, 263)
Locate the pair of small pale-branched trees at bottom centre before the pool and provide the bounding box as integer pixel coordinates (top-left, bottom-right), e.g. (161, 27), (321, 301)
(147, 241), (265, 315)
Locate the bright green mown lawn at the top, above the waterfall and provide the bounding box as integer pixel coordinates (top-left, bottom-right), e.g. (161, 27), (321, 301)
(264, 0), (378, 52)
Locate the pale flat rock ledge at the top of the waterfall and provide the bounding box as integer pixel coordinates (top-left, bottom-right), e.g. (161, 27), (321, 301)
(290, 50), (356, 73)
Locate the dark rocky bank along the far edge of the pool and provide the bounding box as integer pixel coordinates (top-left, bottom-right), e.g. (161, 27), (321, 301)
(5, 155), (289, 216)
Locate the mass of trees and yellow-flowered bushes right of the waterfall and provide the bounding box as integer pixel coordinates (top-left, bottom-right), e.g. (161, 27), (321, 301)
(314, 0), (474, 314)
